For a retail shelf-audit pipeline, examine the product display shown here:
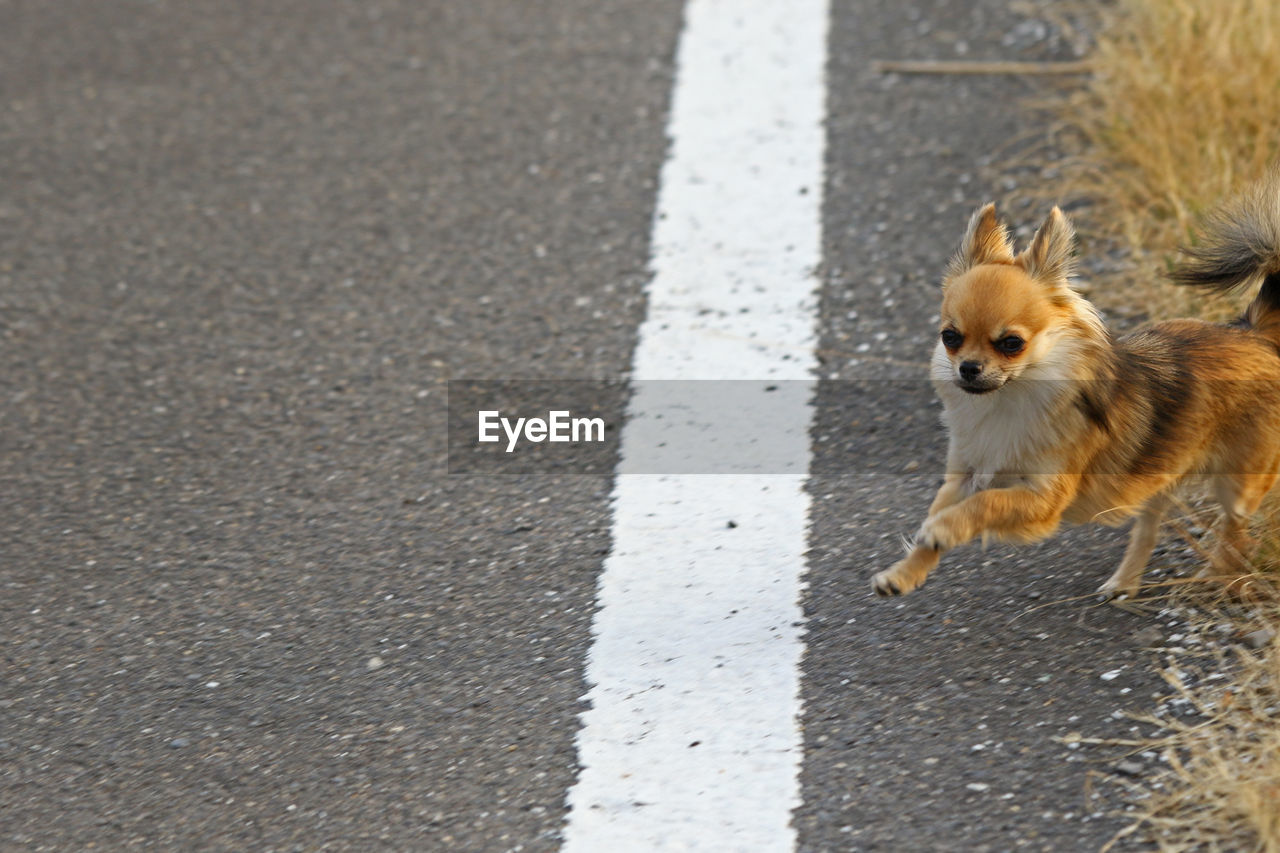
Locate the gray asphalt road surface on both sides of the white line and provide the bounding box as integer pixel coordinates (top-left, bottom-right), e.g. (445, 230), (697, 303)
(0, 0), (1177, 850)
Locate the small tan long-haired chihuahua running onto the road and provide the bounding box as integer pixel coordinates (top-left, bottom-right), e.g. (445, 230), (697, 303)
(873, 179), (1280, 596)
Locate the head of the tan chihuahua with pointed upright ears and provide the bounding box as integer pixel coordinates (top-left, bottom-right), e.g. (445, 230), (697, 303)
(933, 204), (1101, 394)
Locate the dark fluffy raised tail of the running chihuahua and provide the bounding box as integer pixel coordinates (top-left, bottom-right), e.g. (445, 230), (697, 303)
(1171, 167), (1280, 345)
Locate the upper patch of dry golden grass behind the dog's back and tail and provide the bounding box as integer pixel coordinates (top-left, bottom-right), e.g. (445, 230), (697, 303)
(1034, 0), (1280, 318)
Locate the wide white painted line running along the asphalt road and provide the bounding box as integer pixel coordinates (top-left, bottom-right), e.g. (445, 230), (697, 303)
(564, 0), (827, 853)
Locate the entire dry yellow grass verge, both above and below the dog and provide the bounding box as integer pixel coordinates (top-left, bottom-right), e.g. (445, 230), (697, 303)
(1003, 0), (1280, 853)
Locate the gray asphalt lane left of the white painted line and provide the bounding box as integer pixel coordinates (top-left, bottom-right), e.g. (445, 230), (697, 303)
(0, 0), (680, 850)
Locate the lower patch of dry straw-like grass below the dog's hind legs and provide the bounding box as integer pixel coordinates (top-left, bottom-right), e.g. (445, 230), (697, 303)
(1085, 493), (1280, 853)
